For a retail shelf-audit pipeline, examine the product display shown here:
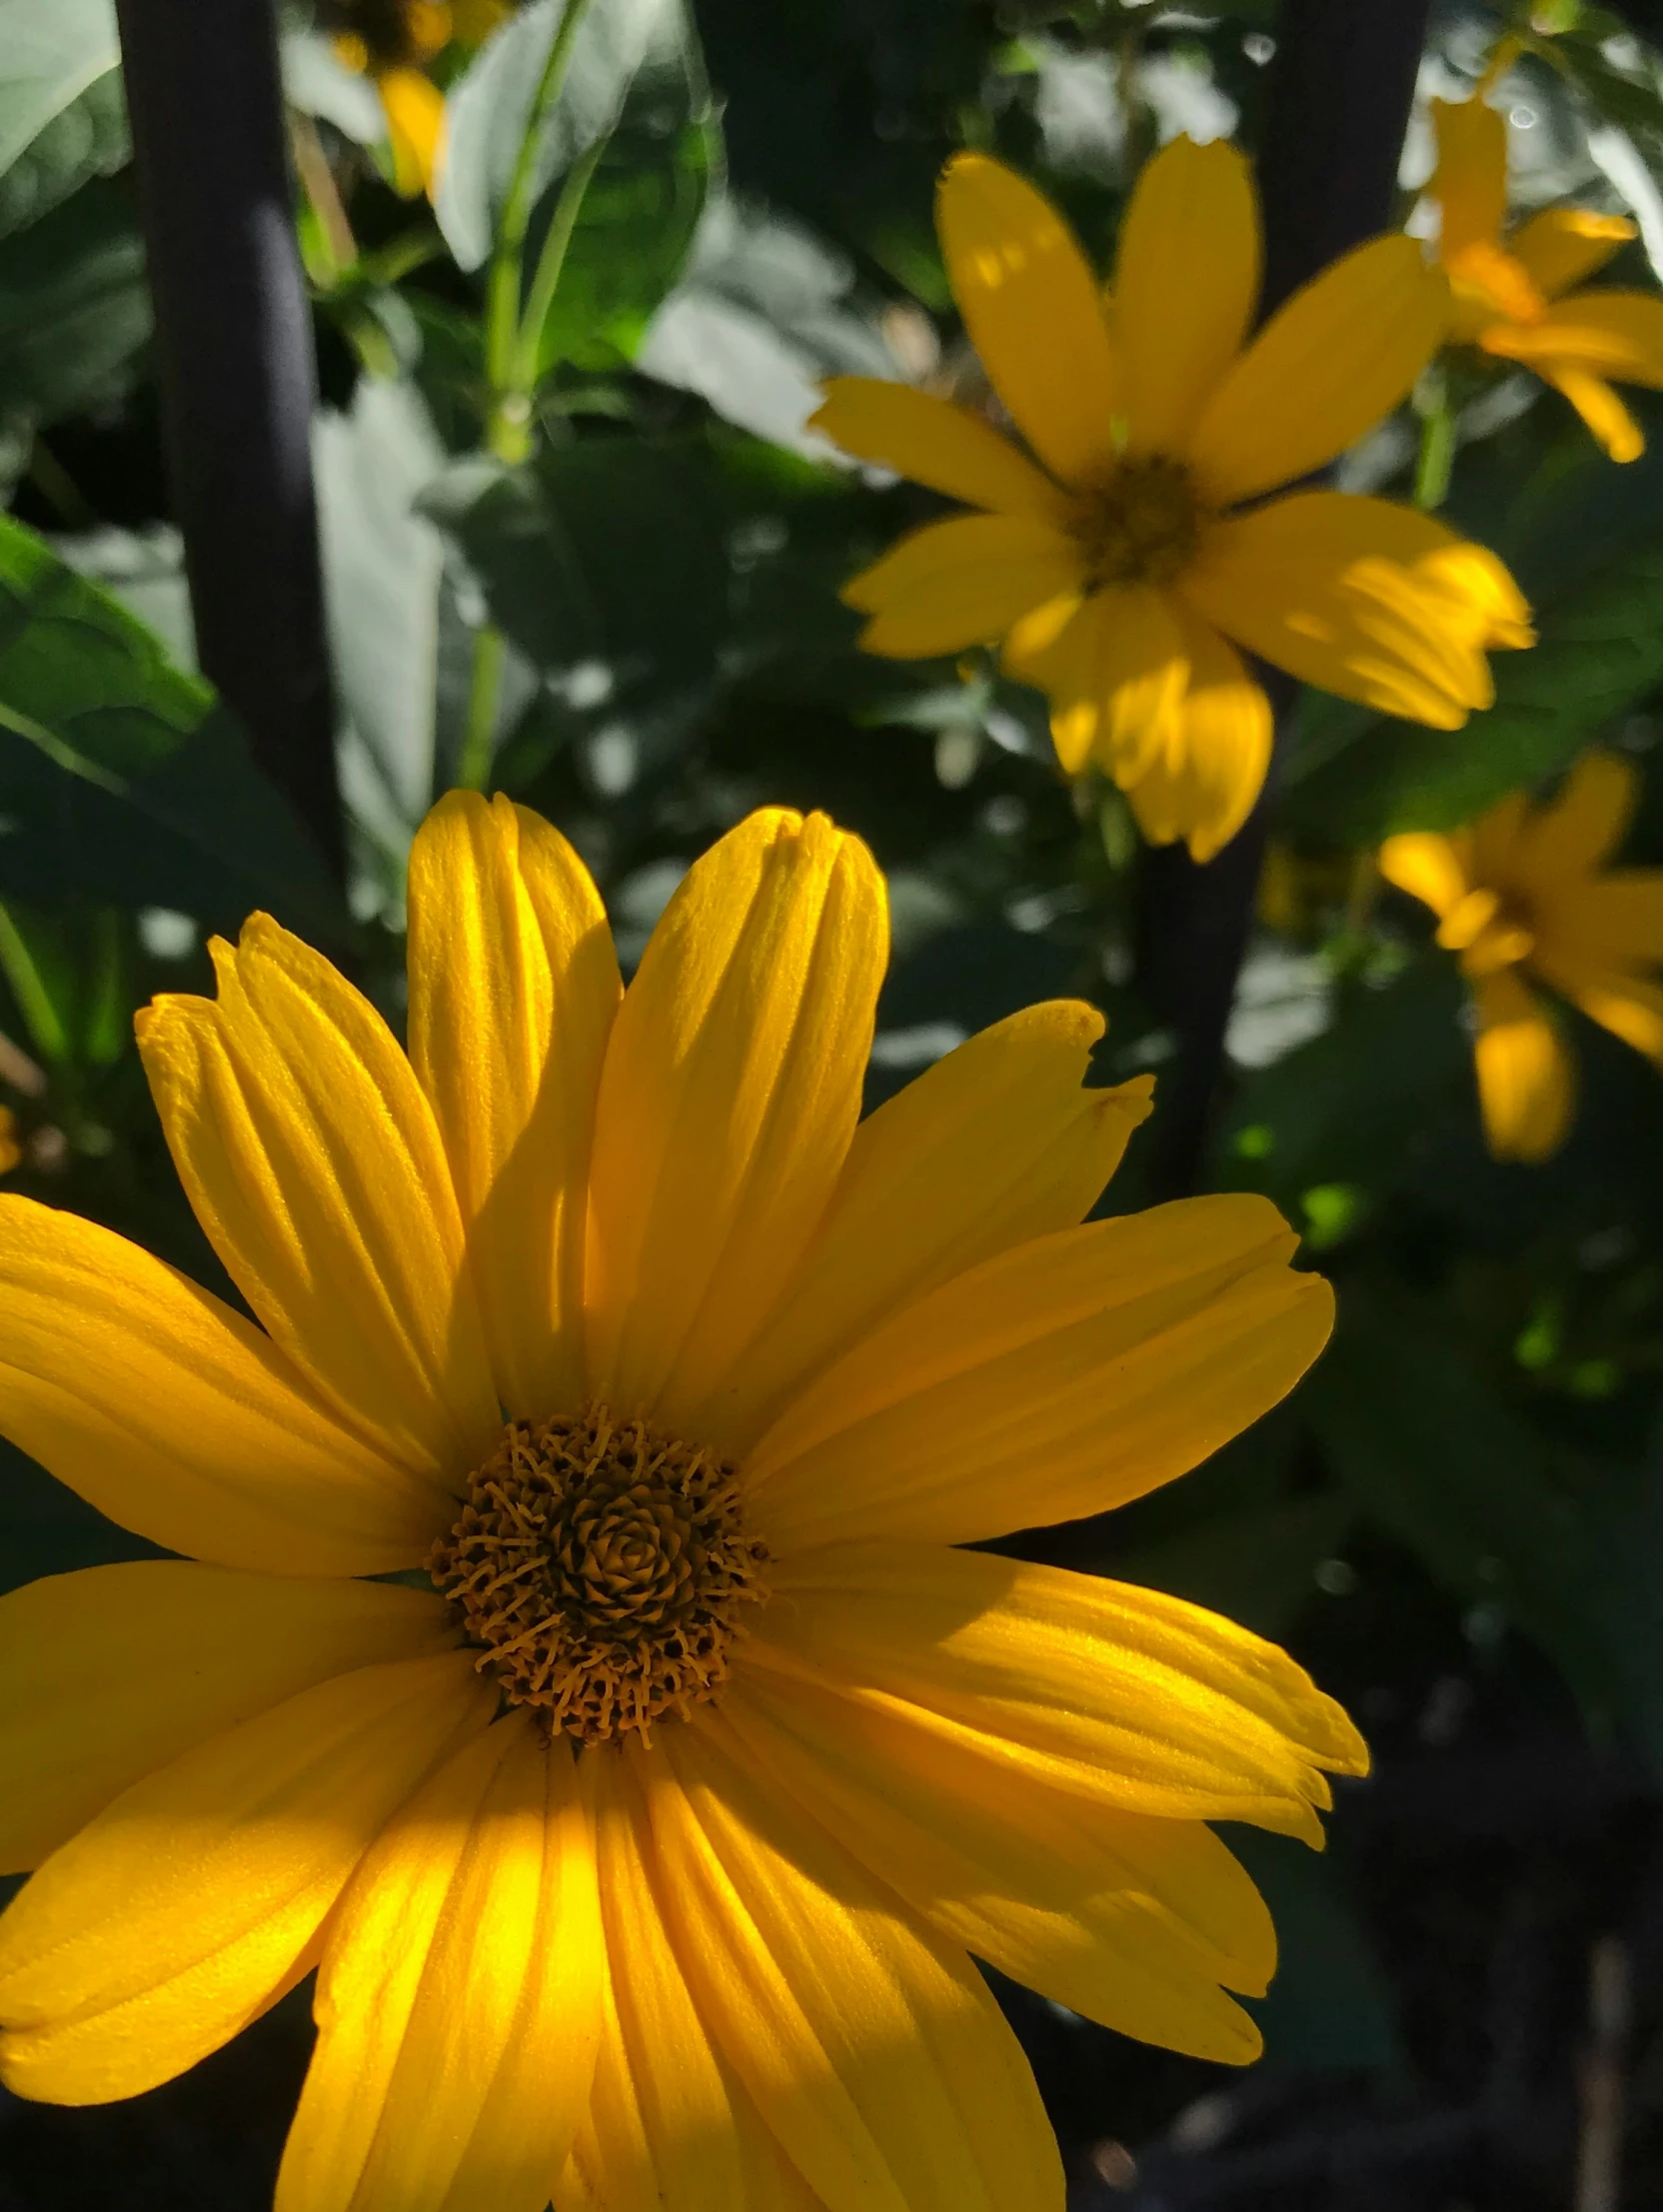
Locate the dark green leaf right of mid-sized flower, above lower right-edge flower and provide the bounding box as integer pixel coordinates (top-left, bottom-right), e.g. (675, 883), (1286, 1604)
(1287, 542), (1663, 845)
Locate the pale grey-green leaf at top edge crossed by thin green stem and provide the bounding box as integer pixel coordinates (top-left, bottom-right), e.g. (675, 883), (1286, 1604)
(434, 0), (688, 270)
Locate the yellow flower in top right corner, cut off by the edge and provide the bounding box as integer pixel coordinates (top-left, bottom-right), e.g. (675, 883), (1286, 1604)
(1426, 100), (1663, 460)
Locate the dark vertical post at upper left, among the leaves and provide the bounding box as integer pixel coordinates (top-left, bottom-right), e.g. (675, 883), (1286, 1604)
(117, 0), (345, 876)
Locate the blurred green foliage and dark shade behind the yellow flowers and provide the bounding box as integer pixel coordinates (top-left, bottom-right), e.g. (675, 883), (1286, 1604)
(0, 0), (1663, 2212)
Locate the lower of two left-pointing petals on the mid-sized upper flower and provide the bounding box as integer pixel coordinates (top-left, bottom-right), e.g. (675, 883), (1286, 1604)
(842, 516), (1079, 659)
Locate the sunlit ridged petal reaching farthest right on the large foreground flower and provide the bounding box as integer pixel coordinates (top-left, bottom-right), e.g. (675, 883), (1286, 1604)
(752, 1541), (1369, 1842)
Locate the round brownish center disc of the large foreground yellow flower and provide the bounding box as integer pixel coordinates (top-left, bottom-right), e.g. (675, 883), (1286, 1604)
(429, 1406), (768, 1743)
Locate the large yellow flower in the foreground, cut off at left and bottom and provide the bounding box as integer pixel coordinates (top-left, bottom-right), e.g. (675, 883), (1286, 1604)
(0, 794), (1366, 2212)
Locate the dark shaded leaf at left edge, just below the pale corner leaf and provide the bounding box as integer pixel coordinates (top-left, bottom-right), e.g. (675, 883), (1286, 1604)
(0, 177), (150, 423)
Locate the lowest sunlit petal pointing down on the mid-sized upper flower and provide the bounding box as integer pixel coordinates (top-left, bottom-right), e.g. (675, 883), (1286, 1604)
(1119, 613), (1271, 861)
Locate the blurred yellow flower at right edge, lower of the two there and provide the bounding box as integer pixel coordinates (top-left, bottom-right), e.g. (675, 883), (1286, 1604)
(1380, 752), (1663, 1161)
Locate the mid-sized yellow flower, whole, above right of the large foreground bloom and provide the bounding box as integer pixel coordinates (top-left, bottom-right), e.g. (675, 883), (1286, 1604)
(814, 139), (1530, 861)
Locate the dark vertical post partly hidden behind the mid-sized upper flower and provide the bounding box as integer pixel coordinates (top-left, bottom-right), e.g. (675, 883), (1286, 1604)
(1136, 0), (1428, 1196)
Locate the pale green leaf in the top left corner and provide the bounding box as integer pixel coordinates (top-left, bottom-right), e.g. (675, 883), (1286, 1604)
(0, 0), (126, 235)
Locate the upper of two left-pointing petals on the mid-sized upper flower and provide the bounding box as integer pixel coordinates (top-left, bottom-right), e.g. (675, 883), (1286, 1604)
(810, 376), (1068, 522)
